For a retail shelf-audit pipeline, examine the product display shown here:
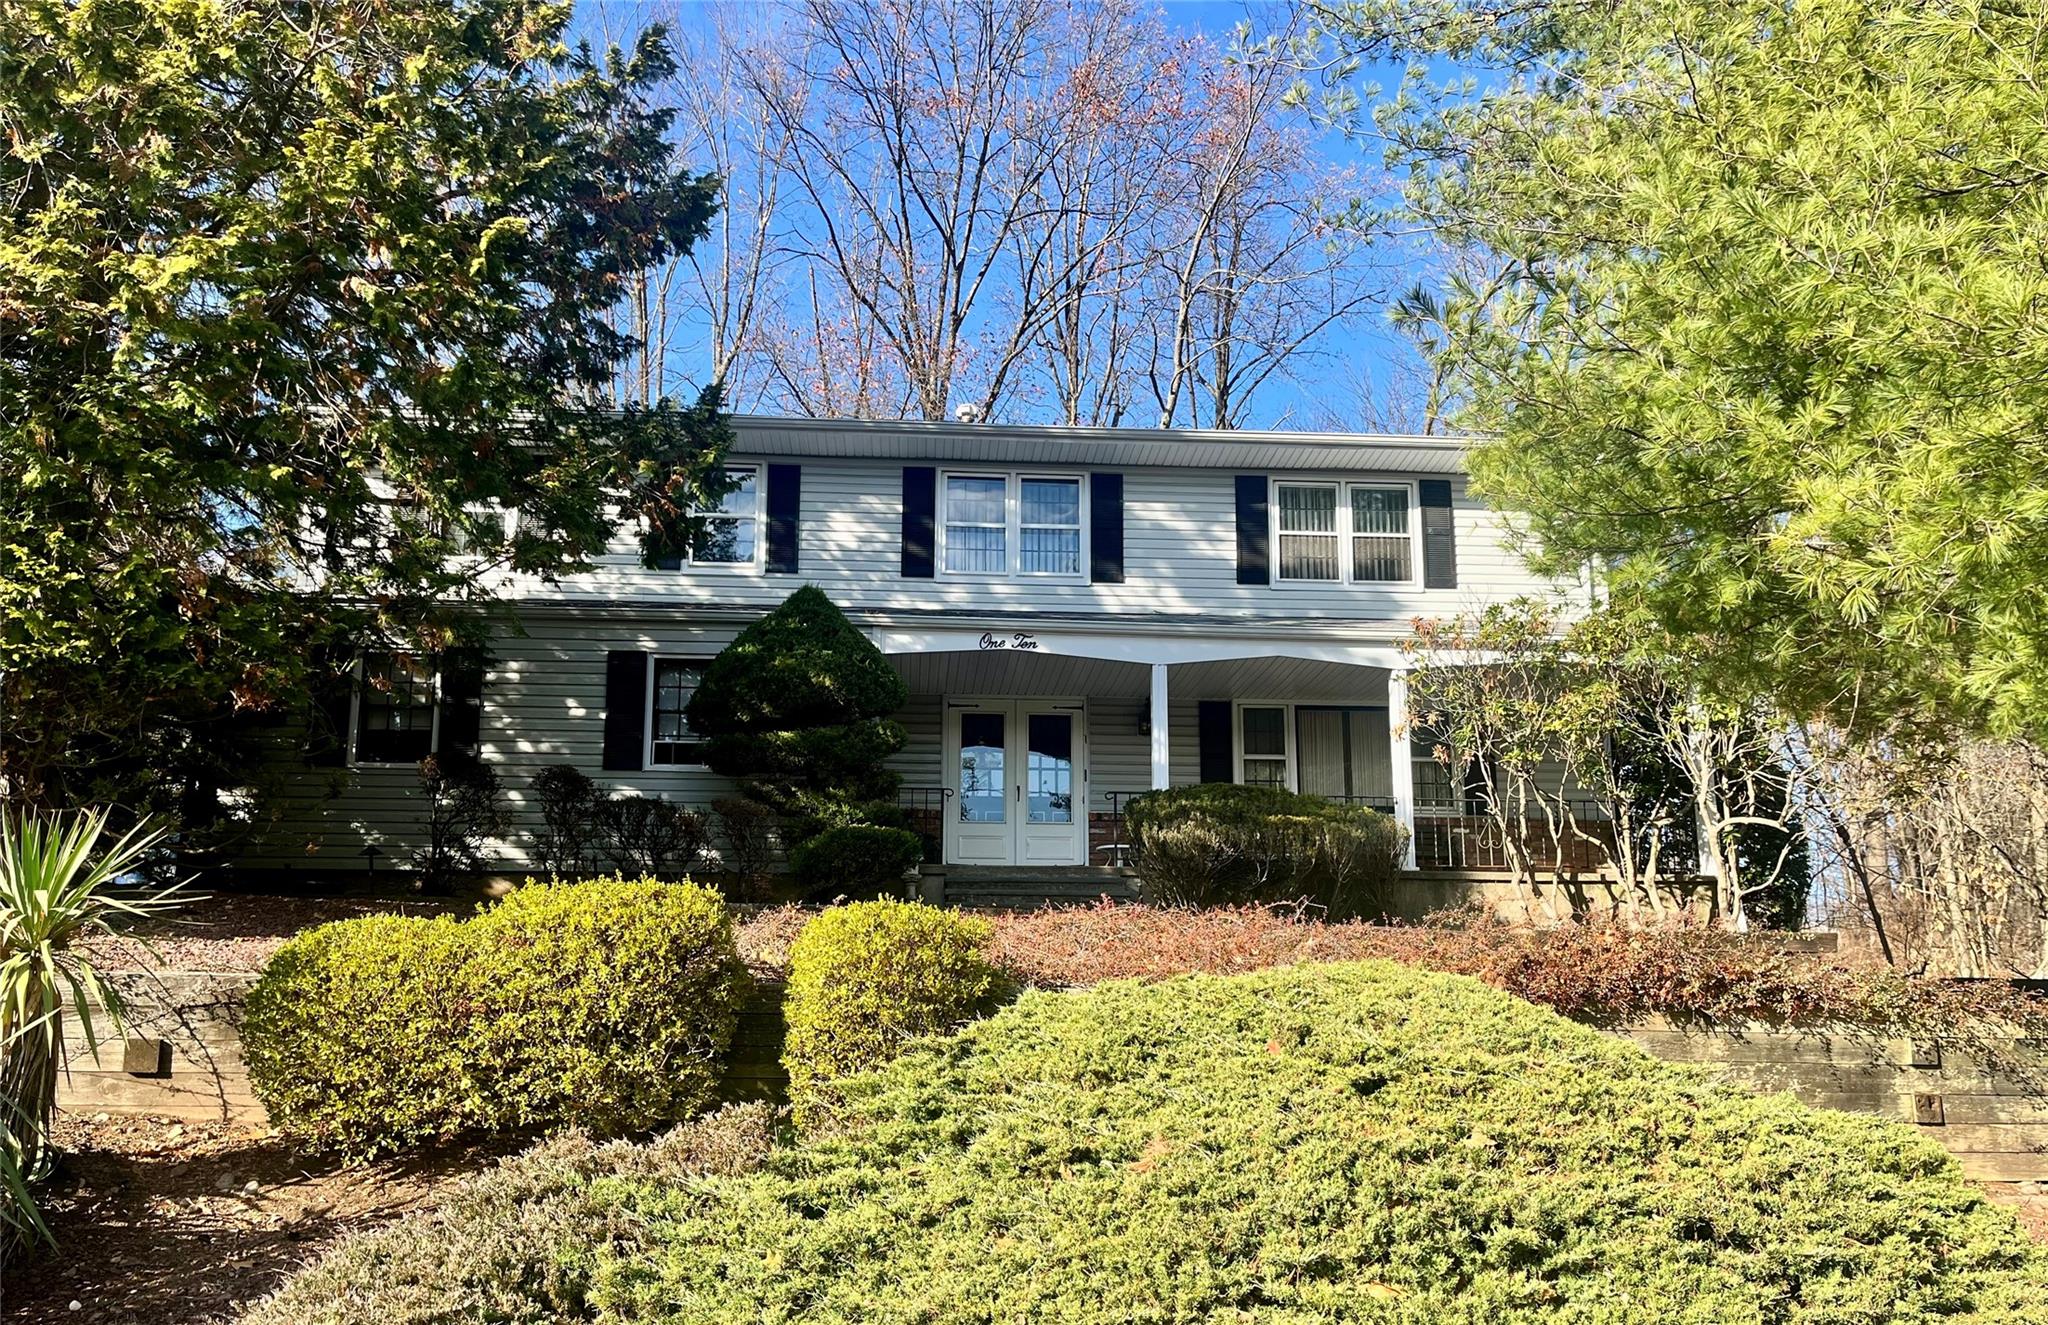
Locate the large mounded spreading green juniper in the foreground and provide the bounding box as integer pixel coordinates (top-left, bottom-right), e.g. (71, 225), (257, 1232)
(260, 963), (2048, 1325)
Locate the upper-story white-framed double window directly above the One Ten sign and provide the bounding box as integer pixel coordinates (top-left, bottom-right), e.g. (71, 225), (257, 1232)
(938, 471), (1087, 580)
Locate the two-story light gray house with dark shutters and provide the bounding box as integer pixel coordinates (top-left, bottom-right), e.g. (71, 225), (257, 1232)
(238, 418), (1581, 896)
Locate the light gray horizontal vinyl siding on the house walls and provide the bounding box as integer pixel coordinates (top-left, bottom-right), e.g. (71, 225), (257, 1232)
(242, 428), (1554, 872)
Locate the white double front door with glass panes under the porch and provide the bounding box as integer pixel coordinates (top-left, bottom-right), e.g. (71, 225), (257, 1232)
(944, 698), (1087, 864)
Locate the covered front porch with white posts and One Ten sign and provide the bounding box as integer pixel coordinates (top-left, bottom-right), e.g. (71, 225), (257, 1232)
(877, 629), (1440, 868)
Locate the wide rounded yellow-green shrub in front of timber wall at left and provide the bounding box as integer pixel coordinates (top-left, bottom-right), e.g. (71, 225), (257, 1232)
(242, 879), (745, 1155)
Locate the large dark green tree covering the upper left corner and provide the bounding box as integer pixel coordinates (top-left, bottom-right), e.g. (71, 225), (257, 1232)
(0, 0), (725, 823)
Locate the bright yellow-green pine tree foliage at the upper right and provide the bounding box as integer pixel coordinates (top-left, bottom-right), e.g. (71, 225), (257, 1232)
(1325, 0), (2048, 739)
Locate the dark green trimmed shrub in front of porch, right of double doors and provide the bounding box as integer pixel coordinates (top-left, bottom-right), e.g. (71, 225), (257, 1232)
(1128, 782), (1407, 917)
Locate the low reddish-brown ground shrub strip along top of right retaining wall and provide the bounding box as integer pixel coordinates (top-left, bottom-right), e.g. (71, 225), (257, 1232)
(991, 903), (2048, 1071)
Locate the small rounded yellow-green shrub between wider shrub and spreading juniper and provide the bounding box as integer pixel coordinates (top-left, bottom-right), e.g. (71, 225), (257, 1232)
(782, 901), (995, 1122)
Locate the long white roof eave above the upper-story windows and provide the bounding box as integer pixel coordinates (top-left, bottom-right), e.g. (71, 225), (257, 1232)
(731, 414), (1470, 473)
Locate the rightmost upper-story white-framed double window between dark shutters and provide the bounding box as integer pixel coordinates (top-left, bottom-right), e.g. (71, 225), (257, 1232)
(1272, 479), (1417, 584)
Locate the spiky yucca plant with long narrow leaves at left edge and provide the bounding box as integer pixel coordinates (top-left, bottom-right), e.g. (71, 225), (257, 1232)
(0, 809), (184, 1179)
